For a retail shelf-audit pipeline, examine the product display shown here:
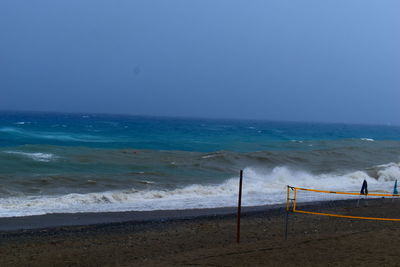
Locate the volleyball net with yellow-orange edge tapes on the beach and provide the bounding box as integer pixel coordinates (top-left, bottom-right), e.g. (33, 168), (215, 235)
(286, 186), (400, 221)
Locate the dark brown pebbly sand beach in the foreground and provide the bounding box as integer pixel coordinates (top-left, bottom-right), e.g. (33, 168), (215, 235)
(0, 199), (400, 266)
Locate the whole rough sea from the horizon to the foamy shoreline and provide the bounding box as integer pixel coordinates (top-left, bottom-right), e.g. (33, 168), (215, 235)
(0, 111), (400, 217)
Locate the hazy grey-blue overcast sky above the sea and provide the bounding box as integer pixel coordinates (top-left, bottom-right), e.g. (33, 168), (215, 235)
(0, 0), (400, 124)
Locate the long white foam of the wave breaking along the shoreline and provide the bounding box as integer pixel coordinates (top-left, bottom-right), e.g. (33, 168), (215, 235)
(0, 163), (400, 217)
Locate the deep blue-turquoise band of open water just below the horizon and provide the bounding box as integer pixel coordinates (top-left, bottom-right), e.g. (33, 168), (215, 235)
(0, 112), (400, 152)
